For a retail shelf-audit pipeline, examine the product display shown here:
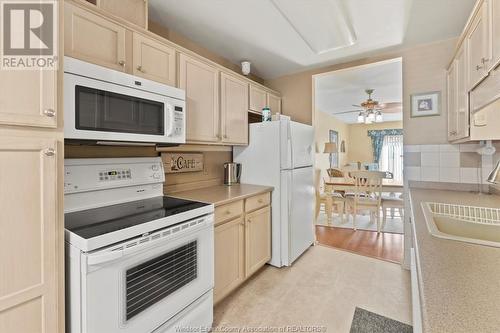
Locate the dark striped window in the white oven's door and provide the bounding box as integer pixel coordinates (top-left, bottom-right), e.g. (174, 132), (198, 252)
(125, 241), (198, 320)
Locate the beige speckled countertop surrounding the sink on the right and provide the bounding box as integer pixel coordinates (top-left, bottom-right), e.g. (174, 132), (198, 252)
(410, 184), (500, 333)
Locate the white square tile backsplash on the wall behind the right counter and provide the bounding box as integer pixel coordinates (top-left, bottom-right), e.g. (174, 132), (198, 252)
(404, 144), (500, 184)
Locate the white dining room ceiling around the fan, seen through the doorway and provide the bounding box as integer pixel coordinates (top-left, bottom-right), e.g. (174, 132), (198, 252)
(314, 58), (403, 124)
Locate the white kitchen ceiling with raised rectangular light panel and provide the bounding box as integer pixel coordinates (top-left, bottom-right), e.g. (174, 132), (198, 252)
(149, 0), (475, 79)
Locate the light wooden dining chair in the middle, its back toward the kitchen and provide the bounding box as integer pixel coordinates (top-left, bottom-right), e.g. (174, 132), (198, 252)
(347, 171), (384, 232)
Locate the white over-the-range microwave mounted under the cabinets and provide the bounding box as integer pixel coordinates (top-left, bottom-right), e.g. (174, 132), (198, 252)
(64, 57), (186, 145)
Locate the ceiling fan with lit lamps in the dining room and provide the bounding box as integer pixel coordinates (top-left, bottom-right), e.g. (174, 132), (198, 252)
(334, 89), (402, 124)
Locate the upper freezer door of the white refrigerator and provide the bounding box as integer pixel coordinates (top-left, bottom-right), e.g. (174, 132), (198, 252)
(290, 121), (314, 169)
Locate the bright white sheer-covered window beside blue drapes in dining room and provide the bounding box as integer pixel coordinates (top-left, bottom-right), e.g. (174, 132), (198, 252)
(379, 135), (403, 183)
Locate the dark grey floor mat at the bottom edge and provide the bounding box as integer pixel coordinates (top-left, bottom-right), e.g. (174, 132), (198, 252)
(349, 307), (413, 333)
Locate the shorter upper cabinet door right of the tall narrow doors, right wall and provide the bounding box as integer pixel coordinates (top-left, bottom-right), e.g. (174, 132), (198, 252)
(465, 1), (491, 89)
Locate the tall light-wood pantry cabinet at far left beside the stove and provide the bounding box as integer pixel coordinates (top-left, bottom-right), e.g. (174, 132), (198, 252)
(0, 1), (64, 332)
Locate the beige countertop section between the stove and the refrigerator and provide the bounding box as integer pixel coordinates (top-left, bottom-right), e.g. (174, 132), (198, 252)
(168, 184), (274, 207)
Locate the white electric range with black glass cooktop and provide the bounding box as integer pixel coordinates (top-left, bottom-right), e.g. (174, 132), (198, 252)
(64, 158), (214, 333)
